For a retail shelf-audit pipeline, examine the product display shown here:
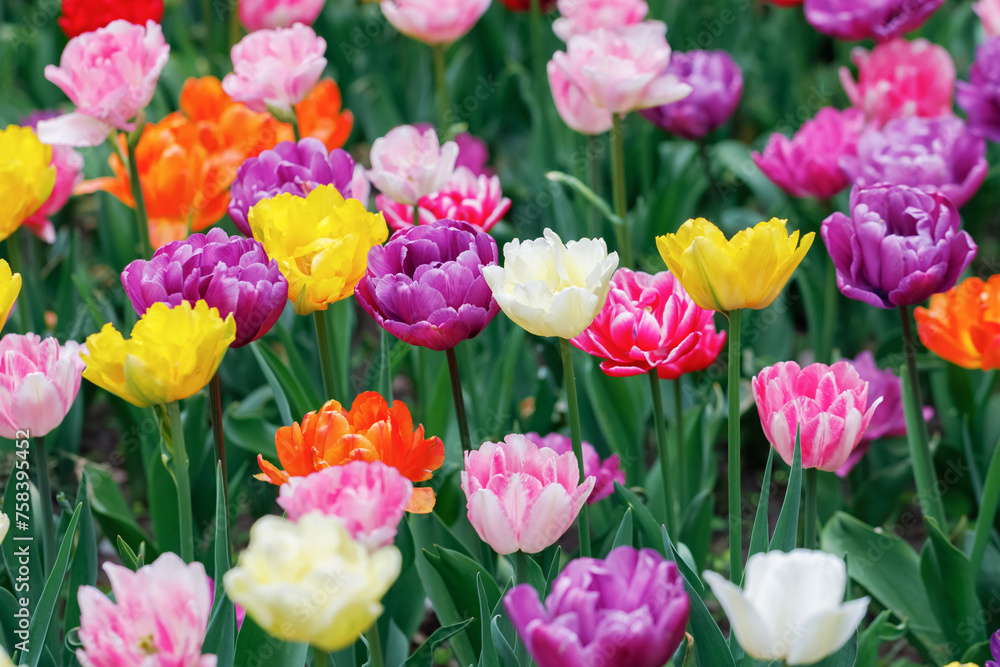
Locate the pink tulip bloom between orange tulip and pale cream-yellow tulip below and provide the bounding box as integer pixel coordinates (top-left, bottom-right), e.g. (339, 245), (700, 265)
(278, 461), (413, 549)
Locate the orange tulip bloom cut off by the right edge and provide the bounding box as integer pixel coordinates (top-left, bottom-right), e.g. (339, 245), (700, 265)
(914, 275), (1000, 371)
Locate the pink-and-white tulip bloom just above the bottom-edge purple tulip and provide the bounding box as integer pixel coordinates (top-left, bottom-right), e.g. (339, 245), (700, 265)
(462, 435), (596, 554)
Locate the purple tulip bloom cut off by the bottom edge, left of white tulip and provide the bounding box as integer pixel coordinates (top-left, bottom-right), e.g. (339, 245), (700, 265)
(504, 546), (691, 667)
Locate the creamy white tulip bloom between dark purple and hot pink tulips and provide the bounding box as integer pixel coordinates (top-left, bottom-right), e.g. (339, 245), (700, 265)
(483, 229), (618, 338)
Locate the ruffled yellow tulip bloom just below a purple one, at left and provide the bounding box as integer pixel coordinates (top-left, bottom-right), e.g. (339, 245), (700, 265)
(80, 301), (236, 408)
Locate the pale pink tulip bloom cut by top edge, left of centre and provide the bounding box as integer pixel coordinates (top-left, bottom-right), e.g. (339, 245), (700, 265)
(382, 0), (490, 44)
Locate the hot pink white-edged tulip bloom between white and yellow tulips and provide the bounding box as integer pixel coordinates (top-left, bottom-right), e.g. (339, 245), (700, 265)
(570, 268), (726, 380)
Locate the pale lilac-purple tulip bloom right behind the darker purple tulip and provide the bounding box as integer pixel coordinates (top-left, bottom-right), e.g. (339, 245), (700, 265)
(840, 116), (990, 207)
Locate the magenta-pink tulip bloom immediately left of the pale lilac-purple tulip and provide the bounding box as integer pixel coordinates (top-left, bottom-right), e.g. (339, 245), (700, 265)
(752, 107), (865, 199)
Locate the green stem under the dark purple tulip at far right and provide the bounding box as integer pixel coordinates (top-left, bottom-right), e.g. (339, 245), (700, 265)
(899, 306), (948, 533)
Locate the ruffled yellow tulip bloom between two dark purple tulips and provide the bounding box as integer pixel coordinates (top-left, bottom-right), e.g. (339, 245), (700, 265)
(249, 185), (389, 315)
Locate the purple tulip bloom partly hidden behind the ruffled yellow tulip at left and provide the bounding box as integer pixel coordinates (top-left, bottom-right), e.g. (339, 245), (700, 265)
(122, 228), (288, 347)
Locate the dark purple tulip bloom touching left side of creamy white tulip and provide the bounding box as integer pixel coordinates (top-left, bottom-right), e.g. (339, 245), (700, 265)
(354, 220), (500, 351)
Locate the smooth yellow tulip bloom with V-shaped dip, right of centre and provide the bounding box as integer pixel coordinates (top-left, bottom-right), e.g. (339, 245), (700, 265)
(656, 218), (816, 313)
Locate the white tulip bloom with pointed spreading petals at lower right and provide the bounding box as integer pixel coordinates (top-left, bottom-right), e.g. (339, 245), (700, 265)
(704, 549), (869, 665)
